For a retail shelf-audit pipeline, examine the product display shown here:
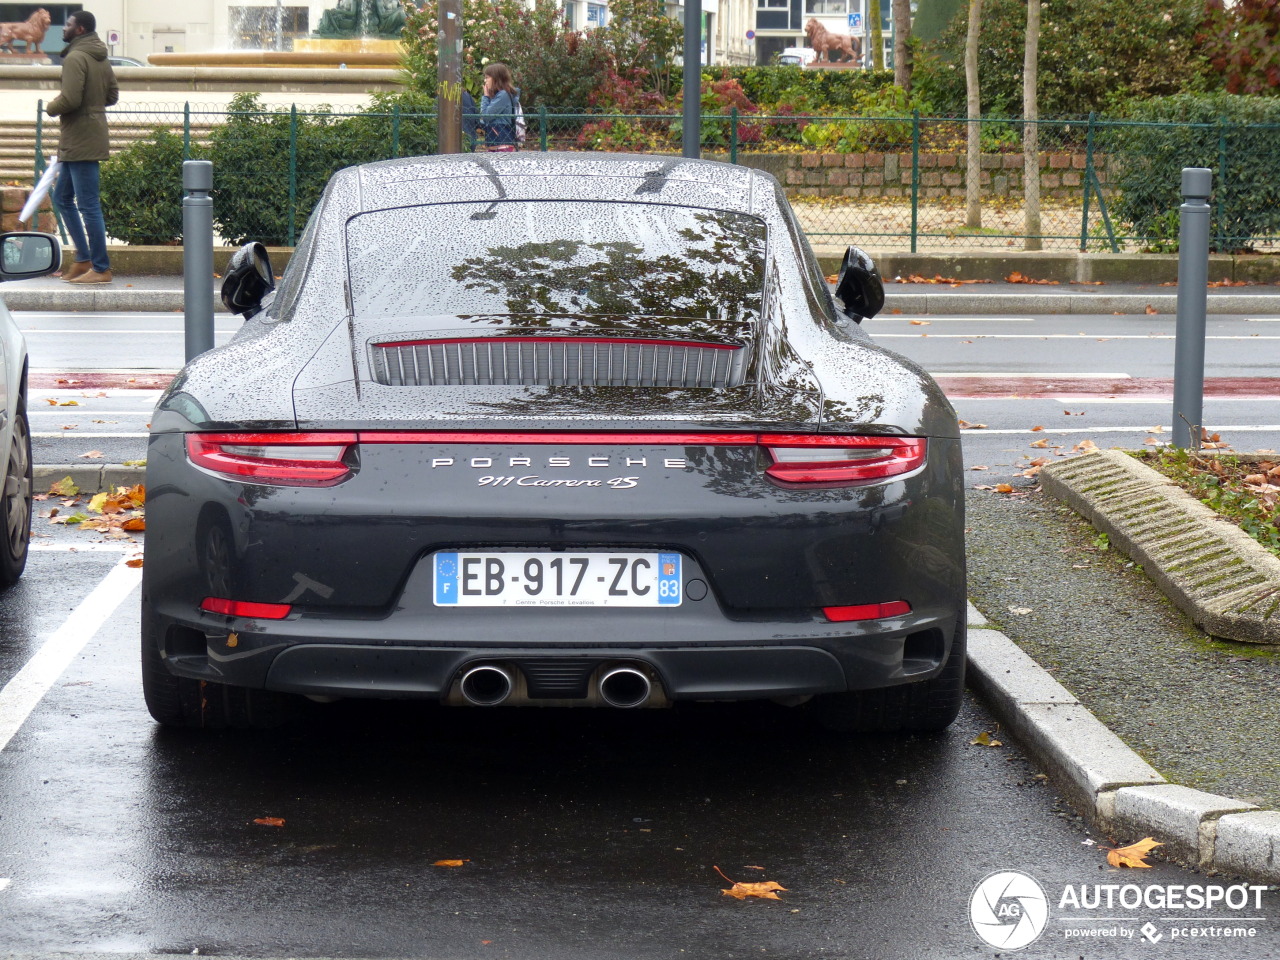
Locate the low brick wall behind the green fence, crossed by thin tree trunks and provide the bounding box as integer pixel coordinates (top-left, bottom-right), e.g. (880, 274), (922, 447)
(762, 152), (1106, 201)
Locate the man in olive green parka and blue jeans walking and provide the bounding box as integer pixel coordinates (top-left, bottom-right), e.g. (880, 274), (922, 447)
(45, 10), (120, 283)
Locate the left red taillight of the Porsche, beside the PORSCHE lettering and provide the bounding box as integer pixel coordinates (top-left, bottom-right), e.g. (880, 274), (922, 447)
(187, 434), (356, 486)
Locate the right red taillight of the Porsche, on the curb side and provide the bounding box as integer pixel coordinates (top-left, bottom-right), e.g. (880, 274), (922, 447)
(760, 434), (927, 484)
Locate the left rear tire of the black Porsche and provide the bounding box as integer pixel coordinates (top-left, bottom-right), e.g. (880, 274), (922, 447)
(142, 600), (302, 730)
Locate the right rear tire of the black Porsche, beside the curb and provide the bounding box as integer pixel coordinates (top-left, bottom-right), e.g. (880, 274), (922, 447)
(809, 614), (966, 733)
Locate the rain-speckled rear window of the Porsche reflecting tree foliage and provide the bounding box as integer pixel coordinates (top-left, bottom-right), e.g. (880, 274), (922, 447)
(347, 201), (765, 320)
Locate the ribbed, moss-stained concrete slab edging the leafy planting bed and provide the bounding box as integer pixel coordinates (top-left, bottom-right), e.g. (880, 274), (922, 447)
(1041, 451), (1280, 644)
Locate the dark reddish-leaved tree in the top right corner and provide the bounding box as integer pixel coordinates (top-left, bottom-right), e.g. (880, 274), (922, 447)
(1202, 0), (1280, 93)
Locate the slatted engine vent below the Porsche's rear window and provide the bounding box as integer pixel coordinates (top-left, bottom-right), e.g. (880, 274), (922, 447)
(372, 337), (746, 389)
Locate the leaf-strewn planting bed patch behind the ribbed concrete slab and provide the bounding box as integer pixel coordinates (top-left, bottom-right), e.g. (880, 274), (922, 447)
(1139, 448), (1280, 556)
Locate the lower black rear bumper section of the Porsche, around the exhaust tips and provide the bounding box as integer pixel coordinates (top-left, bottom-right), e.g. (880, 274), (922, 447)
(143, 609), (961, 703)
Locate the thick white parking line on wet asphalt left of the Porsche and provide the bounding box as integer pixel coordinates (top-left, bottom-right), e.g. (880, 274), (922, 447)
(0, 558), (142, 750)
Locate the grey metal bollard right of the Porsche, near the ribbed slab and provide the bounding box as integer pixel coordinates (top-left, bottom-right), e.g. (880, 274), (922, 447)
(1172, 166), (1213, 448)
